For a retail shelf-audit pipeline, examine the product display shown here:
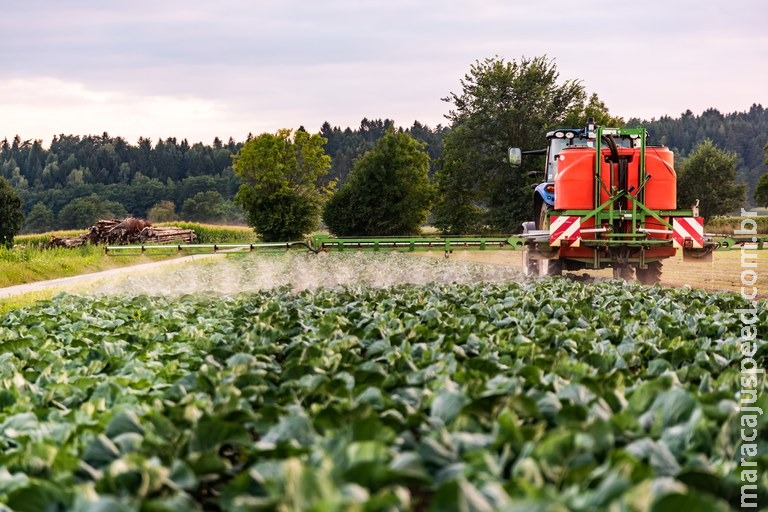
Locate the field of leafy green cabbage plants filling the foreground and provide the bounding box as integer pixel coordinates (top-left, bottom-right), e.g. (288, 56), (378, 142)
(0, 257), (768, 512)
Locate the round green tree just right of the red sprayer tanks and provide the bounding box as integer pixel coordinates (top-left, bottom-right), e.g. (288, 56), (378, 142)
(677, 139), (747, 218)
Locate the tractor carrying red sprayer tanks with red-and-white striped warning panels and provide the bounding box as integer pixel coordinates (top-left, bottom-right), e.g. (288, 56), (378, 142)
(509, 120), (762, 284)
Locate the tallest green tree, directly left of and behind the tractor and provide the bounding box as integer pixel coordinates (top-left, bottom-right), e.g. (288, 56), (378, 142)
(433, 56), (588, 233)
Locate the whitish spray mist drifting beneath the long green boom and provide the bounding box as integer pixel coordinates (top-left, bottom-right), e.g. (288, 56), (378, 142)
(88, 253), (523, 295)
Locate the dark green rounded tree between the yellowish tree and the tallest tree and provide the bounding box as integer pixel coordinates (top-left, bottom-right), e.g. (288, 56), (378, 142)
(323, 129), (433, 236)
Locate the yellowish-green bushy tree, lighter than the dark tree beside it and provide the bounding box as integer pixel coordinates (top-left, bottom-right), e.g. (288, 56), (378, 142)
(232, 129), (334, 241)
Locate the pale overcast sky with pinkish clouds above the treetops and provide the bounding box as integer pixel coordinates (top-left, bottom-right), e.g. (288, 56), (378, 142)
(0, 0), (768, 144)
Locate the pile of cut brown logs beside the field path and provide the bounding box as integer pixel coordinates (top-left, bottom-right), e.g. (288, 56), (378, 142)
(46, 217), (197, 247)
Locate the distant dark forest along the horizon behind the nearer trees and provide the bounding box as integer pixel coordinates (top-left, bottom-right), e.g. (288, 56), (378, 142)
(0, 105), (768, 232)
